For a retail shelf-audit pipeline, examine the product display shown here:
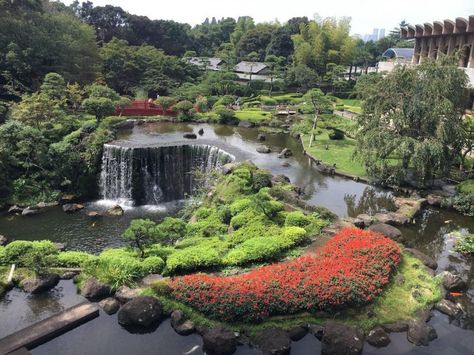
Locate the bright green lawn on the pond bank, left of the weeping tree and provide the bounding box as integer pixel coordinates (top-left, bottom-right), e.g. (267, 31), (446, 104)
(303, 129), (367, 177)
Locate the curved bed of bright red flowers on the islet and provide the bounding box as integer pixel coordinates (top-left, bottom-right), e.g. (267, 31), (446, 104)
(170, 228), (400, 322)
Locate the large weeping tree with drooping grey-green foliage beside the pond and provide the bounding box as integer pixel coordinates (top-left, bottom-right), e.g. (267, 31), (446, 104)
(357, 58), (467, 186)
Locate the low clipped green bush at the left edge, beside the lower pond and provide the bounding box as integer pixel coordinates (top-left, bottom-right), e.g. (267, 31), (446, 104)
(3, 240), (58, 266)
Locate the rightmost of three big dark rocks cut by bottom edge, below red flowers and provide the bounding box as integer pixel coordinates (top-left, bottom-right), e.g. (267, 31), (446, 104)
(321, 322), (364, 355)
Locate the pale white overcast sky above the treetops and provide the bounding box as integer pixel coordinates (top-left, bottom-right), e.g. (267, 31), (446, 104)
(63, 0), (474, 35)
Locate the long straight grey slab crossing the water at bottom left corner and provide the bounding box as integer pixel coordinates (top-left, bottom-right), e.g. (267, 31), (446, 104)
(0, 302), (99, 354)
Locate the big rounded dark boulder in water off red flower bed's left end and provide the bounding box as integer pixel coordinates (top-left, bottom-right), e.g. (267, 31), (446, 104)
(118, 296), (163, 327)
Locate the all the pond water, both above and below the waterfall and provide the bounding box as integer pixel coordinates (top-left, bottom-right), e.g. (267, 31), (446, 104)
(0, 123), (474, 354)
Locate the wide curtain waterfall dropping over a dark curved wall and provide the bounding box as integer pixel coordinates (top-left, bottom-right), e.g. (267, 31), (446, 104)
(100, 144), (235, 205)
